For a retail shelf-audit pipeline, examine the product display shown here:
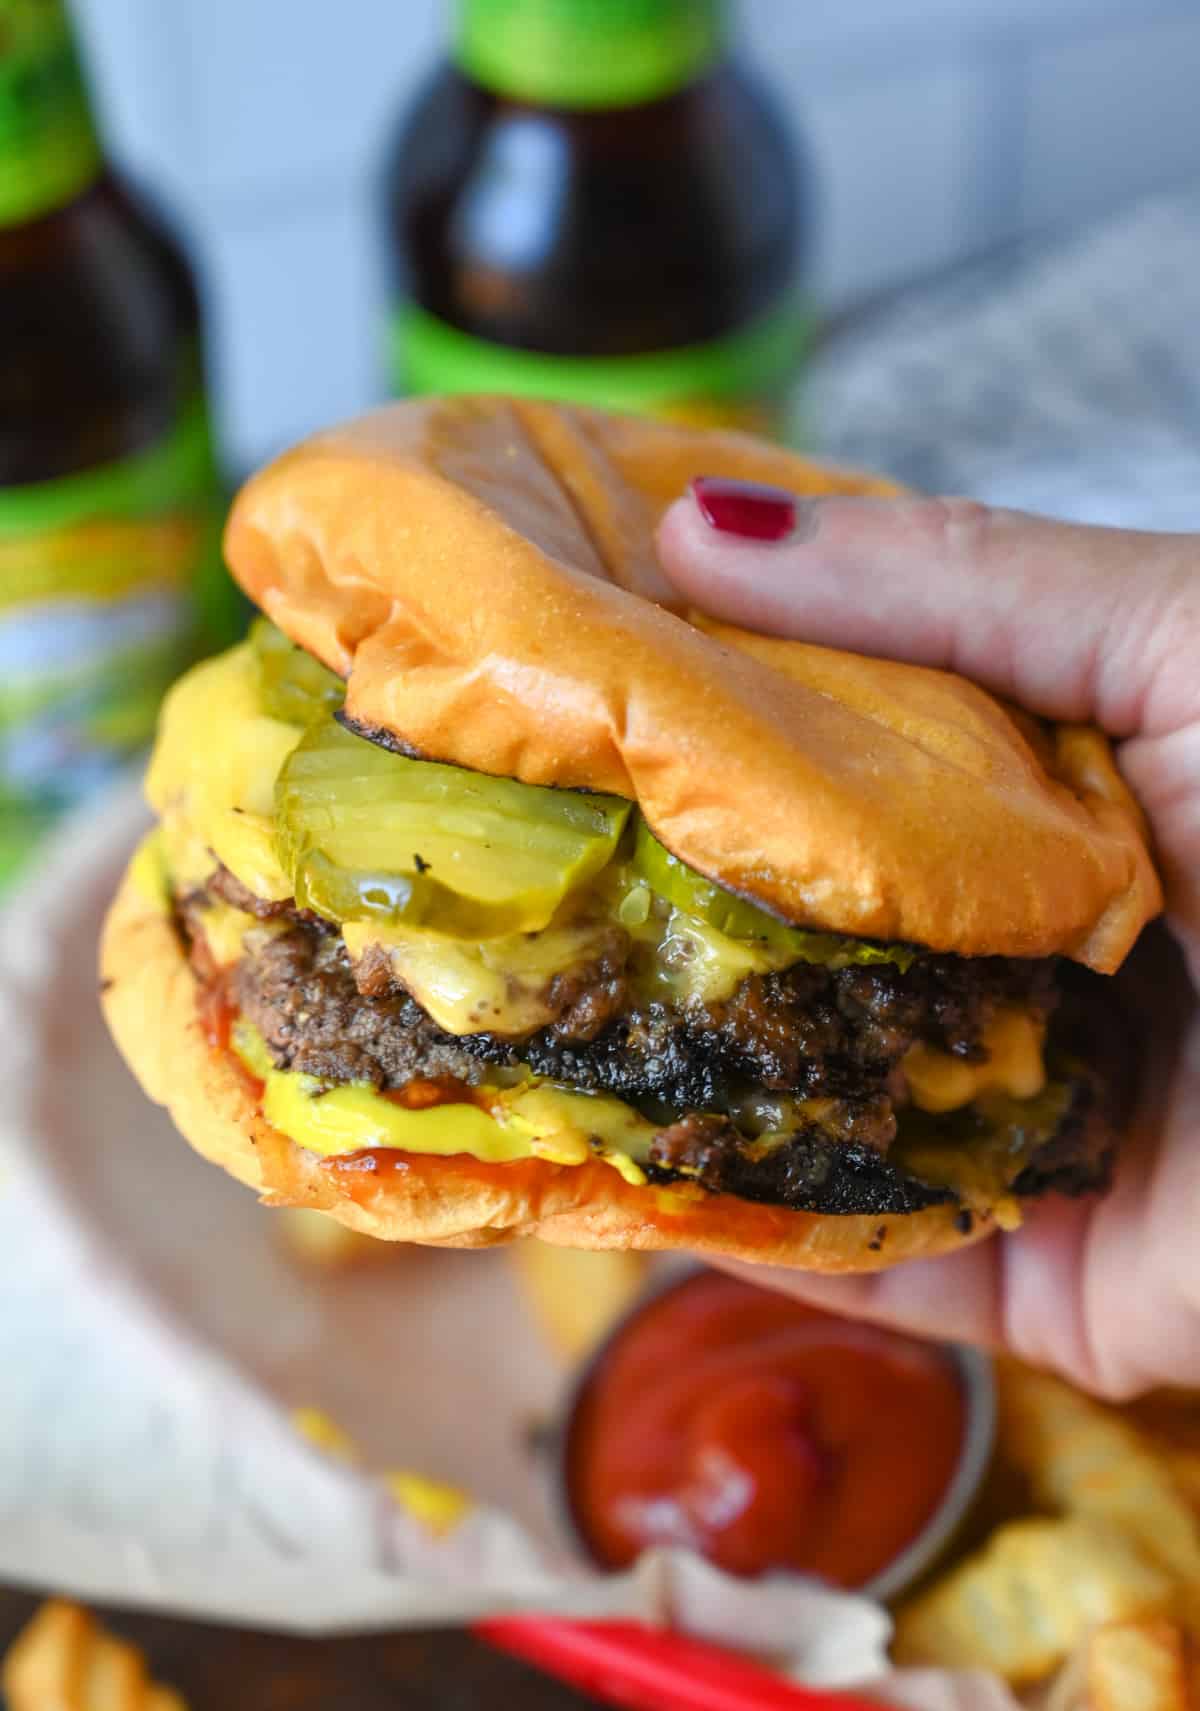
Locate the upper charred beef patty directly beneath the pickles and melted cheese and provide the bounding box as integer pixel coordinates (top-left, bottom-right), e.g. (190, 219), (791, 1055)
(215, 921), (1054, 1108)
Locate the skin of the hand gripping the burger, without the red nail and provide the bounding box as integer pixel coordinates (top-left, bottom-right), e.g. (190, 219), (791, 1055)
(659, 491), (1200, 1396)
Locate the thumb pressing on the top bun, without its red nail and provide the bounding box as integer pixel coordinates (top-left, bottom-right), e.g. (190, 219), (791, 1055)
(659, 491), (1200, 736)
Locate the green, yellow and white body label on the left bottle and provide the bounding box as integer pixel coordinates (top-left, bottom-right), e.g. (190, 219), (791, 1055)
(0, 400), (229, 879)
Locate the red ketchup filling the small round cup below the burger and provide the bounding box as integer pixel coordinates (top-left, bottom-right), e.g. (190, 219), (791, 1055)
(567, 1273), (967, 1588)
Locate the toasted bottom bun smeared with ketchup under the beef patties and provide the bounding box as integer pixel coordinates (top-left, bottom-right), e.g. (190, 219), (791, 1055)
(101, 864), (995, 1273)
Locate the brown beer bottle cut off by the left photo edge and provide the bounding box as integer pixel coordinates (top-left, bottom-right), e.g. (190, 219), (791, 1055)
(0, 0), (236, 881)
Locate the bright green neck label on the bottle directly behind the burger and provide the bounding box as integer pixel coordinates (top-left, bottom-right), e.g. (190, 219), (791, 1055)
(454, 0), (726, 108)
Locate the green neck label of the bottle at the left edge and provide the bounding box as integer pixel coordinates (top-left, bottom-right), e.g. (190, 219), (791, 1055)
(0, 0), (103, 228)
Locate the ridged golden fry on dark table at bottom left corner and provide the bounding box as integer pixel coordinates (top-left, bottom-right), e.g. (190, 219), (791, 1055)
(0, 1598), (187, 1711)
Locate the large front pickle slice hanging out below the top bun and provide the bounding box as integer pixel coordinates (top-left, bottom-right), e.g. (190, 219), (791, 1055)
(276, 719), (630, 939)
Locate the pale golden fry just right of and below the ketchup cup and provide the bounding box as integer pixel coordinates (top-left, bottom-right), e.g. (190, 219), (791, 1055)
(894, 1518), (1176, 1685)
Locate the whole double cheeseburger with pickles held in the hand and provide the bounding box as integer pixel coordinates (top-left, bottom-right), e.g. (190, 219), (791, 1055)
(103, 399), (1159, 1271)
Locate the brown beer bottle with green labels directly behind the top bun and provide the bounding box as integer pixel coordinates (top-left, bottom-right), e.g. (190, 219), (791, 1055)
(387, 0), (808, 429)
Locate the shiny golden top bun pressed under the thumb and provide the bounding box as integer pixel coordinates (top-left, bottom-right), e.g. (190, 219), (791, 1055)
(226, 397), (1161, 972)
